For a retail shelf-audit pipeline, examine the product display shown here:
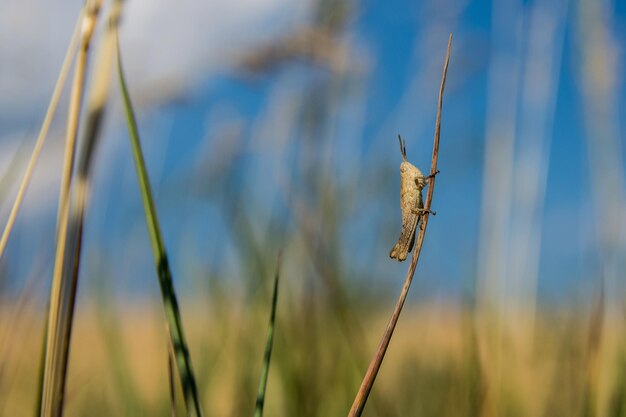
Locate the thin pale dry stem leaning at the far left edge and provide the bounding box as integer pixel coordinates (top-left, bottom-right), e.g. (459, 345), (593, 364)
(0, 11), (84, 258)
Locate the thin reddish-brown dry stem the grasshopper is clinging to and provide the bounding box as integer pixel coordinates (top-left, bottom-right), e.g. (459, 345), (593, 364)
(348, 34), (452, 417)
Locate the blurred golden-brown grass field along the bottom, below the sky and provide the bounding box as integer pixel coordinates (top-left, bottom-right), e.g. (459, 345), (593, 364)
(0, 300), (625, 416)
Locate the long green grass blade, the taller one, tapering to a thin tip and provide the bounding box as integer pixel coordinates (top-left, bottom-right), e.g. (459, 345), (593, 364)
(115, 28), (202, 416)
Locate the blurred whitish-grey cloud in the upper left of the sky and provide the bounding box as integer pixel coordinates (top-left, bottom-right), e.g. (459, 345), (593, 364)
(0, 0), (311, 122)
